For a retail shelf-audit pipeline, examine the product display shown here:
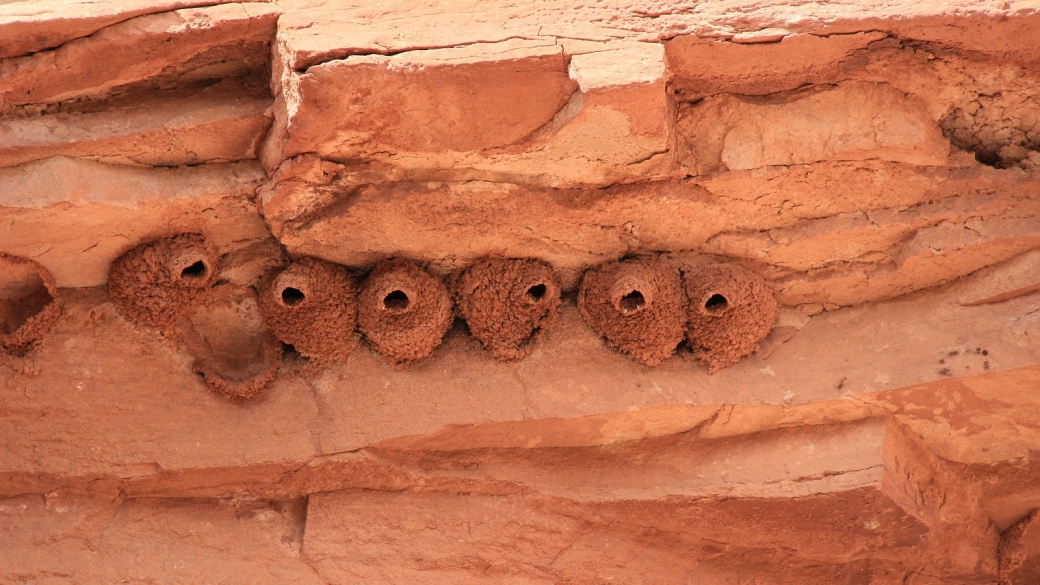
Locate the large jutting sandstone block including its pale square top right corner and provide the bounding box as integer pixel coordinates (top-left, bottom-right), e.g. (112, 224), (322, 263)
(264, 41), (672, 185)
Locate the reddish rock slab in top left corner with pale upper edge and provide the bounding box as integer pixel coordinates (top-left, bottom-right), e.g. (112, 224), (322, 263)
(0, 3), (278, 109)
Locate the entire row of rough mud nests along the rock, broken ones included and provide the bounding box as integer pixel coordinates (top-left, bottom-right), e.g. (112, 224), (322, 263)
(30, 233), (777, 400)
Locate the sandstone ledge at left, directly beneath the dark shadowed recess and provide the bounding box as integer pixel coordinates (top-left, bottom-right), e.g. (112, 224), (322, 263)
(0, 85), (270, 167)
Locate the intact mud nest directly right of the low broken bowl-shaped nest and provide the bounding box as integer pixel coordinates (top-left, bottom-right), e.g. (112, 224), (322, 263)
(258, 258), (358, 360)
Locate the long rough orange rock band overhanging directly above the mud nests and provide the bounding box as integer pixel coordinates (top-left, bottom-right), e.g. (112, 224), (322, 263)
(260, 159), (1038, 306)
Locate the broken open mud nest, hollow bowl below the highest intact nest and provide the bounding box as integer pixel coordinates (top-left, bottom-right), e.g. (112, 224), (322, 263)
(174, 284), (282, 401)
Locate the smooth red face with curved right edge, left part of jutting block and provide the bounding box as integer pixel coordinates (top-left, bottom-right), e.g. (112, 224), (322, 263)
(272, 42), (575, 159)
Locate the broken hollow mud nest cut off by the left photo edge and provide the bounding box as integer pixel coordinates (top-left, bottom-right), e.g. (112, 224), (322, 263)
(0, 252), (61, 355)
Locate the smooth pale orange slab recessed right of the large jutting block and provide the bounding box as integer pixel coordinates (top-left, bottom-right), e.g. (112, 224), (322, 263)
(676, 82), (950, 175)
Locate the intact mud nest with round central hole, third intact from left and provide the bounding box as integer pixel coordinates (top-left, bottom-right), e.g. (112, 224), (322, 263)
(358, 259), (453, 363)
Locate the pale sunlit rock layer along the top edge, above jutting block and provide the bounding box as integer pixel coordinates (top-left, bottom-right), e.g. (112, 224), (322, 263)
(280, 0), (1040, 70)
